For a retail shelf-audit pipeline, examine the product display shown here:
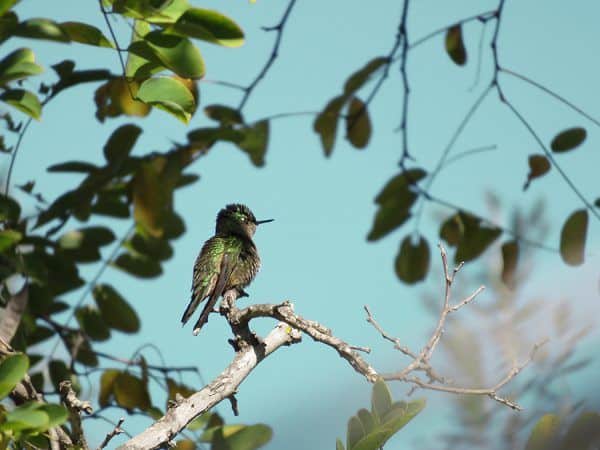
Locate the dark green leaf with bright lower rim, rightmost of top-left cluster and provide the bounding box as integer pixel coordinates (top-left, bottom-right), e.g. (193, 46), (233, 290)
(170, 8), (244, 47)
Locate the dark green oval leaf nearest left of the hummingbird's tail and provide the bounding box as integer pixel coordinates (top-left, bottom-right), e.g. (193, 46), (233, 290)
(93, 284), (140, 333)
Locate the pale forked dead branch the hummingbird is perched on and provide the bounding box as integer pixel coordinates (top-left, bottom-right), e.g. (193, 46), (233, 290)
(119, 245), (543, 450)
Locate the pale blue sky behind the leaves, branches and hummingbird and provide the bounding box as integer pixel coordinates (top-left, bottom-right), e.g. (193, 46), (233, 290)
(4, 0), (600, 450)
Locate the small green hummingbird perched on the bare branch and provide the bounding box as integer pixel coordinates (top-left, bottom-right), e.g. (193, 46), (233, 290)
(181, 203), (274, 336)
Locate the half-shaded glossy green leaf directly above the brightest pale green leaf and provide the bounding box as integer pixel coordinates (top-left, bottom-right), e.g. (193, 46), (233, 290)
(129, 31), (205, 78)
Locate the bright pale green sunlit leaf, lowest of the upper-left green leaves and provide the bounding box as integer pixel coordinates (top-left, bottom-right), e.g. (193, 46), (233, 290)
(137, 77), (196, 124)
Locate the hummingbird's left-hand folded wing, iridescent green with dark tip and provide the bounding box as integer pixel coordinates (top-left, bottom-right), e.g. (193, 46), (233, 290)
(181, 237), (225, 324)
